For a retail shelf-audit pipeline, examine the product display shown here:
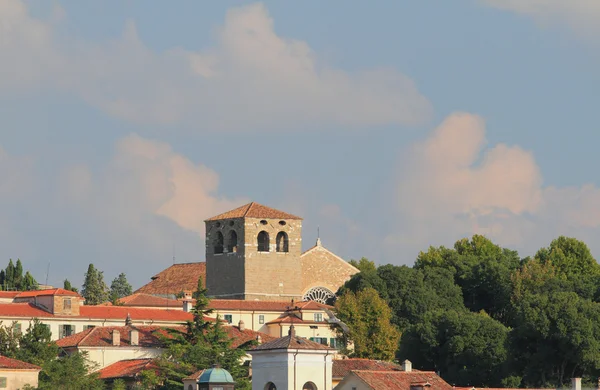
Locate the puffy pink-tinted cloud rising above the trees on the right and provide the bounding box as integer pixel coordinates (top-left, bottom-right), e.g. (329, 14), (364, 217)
(386, 113), (600, 261)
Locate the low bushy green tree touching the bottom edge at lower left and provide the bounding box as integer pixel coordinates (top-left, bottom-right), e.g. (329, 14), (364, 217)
(38, 352), (104, 390)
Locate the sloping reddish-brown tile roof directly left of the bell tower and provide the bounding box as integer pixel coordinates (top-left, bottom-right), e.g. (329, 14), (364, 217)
(135, 262), (206, 295)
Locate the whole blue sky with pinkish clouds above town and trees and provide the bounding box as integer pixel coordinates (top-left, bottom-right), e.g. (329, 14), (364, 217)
(0, 0), (600, 288)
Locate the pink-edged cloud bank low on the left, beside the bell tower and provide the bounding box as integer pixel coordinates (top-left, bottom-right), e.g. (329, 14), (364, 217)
(0, 135), (246, 286)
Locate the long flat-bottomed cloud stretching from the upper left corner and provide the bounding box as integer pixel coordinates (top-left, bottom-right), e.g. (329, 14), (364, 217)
(0, 0), (431, 132)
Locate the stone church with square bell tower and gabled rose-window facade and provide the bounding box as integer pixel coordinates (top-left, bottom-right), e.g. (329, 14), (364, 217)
(205, 202), (359, 303)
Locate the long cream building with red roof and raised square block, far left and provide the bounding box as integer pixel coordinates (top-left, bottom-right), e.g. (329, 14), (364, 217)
(0, 288), (193, 340)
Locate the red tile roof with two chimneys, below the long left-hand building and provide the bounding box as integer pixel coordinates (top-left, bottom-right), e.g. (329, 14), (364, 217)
(56, 326), (185, 348)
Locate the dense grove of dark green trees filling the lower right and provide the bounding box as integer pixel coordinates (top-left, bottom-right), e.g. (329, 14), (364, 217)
(336, 235), (600, 388)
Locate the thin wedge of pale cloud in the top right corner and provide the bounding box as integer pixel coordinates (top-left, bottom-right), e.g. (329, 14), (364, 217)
(482, 0), (600, 37)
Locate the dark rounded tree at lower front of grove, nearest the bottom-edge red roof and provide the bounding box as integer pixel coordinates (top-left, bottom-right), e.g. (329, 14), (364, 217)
(399, 310), (510, 387)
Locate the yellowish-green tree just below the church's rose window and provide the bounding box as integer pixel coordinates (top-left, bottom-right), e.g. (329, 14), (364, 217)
(335, 288), (400, 360)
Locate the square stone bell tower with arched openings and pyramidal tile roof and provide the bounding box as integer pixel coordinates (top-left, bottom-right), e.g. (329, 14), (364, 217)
(204, 202), (302, 301)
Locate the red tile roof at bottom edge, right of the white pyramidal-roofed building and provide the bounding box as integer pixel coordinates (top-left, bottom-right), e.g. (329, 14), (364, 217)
(352, 370), (452, 390)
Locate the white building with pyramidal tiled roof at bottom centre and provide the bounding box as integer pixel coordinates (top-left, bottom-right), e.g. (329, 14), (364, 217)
(249, 325), (335, 390)
